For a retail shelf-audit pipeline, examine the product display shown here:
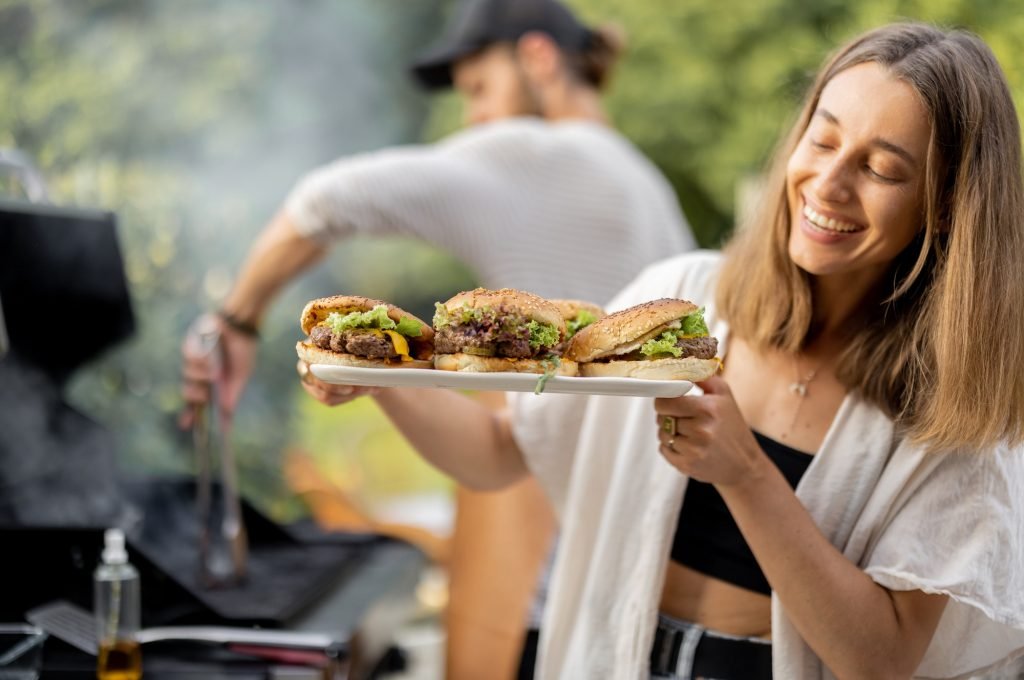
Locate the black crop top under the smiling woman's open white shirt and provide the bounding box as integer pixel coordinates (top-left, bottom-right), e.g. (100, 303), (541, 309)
(672, 432), (813, 595)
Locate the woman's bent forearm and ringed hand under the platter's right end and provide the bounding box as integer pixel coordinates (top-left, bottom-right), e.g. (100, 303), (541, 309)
(655, 378), (947, 679)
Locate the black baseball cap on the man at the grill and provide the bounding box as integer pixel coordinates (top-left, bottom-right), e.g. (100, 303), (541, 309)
(412, 0), (591, 89)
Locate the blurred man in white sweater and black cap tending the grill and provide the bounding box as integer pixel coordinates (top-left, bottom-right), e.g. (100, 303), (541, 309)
(183, 0), (694, 678)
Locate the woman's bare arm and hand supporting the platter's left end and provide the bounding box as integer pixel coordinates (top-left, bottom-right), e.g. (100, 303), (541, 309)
(302, 376), (528, 491)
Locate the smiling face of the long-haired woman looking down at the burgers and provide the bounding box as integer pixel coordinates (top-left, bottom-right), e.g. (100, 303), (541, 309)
(786, 62), (931, 284)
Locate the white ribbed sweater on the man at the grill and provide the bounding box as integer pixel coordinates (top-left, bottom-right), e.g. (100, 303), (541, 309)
(285, 118), (694, 302)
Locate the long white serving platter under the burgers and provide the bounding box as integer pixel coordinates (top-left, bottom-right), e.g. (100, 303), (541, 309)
(309, 364), (693, 397)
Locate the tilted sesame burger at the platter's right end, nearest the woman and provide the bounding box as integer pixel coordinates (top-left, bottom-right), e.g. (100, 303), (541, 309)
(565, 298), (721, 381)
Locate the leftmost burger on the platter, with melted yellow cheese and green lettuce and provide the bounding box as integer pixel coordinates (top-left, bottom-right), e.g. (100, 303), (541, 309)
(295, 295), (434, 369)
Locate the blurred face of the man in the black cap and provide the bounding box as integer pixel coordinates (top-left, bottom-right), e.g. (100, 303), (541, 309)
(452, 44), (540, 125)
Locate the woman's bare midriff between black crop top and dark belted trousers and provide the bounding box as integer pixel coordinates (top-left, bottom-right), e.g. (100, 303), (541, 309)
(660, 561), (771, 639)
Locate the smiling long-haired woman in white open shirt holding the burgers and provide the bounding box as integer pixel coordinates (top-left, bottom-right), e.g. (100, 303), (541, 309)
(306, 24), (1024, 679)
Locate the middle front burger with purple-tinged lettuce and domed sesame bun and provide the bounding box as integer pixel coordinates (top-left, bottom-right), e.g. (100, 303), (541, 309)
(434, 288), (577, 376)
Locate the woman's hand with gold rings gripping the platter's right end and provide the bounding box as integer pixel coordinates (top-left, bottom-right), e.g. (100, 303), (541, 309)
(654, 376), (768, 486)
